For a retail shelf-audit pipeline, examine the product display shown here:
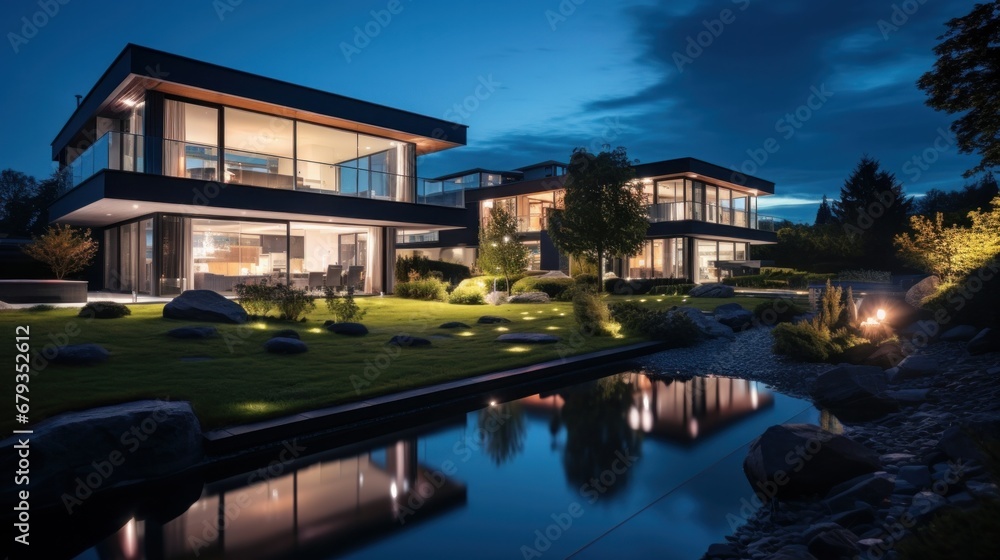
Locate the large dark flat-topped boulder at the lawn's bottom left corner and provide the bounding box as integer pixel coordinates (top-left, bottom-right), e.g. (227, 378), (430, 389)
(0, 400), (203, 511)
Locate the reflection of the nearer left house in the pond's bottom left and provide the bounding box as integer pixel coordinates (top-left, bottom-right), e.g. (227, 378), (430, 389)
(101, 439), (466, 560)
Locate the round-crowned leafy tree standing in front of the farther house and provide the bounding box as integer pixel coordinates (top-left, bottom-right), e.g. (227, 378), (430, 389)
(548, 147), (649, 290)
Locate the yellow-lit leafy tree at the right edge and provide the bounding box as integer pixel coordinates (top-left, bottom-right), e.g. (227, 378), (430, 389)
(895, 196), (1000, 282)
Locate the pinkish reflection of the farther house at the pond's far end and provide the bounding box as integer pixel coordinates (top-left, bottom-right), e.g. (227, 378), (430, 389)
(523, 373), (774, 442)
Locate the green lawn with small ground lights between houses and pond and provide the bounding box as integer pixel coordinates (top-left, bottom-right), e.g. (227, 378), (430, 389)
(0, 296), (796, 429)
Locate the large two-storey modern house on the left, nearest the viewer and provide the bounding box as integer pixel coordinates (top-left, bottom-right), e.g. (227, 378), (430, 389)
(50, 44), (468, 296)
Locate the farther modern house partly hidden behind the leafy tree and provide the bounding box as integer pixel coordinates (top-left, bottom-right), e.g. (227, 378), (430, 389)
(397, 158), (777, 283)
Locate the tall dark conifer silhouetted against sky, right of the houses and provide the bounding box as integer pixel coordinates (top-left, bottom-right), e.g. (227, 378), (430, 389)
(832, 155), (913, 268)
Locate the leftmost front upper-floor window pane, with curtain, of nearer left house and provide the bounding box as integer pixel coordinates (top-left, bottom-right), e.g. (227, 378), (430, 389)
(163, 99), (219, 181)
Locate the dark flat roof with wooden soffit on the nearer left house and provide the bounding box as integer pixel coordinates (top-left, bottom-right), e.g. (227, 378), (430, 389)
(52, 43), (468, 159)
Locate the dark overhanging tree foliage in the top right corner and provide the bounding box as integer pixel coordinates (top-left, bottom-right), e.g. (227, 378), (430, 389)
(917, 0), (1000, 177)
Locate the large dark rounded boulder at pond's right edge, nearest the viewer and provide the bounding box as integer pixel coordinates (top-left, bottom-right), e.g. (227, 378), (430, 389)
(743, 424), (882, 500)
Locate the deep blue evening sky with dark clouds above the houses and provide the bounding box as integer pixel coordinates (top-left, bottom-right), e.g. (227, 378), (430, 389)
(0, 0), (978, 221)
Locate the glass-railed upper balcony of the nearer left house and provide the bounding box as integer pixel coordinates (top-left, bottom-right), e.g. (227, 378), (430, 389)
(69, 132), (465, 208)
